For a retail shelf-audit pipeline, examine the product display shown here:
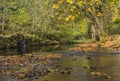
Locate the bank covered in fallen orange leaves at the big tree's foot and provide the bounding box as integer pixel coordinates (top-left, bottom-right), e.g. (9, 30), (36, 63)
(68, 35), (120, 52)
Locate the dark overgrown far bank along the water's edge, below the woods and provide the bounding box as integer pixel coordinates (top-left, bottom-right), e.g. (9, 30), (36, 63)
(0, 35), (91, 49)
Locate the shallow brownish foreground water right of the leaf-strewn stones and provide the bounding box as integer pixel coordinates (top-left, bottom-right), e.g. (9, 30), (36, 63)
(35, 55), (120, 81)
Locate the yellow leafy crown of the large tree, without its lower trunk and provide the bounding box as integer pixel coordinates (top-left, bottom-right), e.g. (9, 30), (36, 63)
(53, 0), (104, 21)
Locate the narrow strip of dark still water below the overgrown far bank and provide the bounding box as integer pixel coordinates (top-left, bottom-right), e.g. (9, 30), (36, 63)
(0, 44), (76, 55)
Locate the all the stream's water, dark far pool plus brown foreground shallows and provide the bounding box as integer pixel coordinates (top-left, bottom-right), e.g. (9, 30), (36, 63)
(0, 45), (120, 81)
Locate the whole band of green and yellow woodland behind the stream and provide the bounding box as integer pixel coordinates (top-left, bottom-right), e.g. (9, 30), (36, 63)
(0, 0), (120, 47)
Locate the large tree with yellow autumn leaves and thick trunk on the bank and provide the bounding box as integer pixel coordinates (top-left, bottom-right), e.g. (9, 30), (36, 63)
(53, 0), (118, 41)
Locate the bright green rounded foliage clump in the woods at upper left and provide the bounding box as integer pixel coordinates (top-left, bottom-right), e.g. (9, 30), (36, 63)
(9, 8), (29, 32)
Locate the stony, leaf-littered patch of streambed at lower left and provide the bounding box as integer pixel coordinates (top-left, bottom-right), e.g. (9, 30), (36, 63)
(0, 54), (61, 81)
